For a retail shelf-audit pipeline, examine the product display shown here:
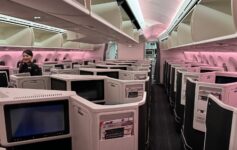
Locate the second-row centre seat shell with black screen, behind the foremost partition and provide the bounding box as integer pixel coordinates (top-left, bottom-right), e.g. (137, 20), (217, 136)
(51, 74), (146, 105)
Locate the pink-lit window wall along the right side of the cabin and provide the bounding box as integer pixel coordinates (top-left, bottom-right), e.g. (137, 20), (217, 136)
(160, 47), (237, 83)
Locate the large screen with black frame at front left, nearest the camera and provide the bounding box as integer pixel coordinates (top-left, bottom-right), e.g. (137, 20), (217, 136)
(4, 100), (69, 142)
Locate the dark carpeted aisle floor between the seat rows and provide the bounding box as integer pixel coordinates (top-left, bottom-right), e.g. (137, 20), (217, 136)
(150, 84), (182, 150)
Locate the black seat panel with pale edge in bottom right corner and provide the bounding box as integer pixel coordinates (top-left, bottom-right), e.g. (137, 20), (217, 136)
(204, 94), (237, 150)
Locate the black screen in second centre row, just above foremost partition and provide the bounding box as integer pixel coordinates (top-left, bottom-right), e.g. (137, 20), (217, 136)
(71, 80), (104, 101)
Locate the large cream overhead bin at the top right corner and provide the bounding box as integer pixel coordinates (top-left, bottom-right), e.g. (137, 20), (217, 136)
(191, 0), (236, 42)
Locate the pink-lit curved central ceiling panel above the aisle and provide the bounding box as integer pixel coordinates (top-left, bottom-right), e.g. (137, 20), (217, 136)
(139, 0), (184, 40)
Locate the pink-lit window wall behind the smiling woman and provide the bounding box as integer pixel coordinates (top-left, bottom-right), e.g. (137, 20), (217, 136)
(0, 45), (104, 68)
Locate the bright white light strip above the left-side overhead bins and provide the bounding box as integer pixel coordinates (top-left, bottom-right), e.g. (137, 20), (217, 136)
(0, 14), (66, 33)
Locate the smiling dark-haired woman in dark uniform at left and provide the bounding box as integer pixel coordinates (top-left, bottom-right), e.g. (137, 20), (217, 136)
(19, 49), (42, 76)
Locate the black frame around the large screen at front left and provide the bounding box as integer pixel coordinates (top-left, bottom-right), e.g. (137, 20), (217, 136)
(4, 99), (70, 142)
